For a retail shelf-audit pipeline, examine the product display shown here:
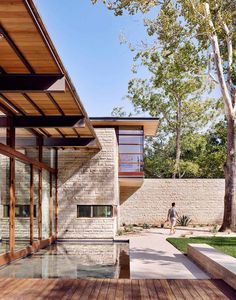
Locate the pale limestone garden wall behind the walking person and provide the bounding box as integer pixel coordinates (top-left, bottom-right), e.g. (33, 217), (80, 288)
(120, 179), (224, 224)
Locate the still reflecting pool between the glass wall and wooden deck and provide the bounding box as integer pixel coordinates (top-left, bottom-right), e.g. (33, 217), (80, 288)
(0, 242), (130, 278)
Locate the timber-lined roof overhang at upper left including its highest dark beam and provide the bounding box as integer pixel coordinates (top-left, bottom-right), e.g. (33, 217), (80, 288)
(0, 0), (101, 149)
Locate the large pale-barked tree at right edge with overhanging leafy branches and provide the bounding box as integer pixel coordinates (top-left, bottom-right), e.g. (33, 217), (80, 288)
(94, 0), (236, 231)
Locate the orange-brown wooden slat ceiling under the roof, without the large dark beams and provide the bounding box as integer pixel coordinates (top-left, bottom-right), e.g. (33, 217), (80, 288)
(0, 0), (99, 147)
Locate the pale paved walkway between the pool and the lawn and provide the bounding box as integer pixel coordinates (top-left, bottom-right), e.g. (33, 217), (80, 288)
(117, 228), (230, 279)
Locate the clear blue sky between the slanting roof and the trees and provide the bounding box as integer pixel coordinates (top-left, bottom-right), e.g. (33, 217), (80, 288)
(35, 0), (148, 116)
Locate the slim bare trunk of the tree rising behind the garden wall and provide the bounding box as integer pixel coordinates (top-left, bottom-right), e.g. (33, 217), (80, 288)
(172, 100), (182, 179)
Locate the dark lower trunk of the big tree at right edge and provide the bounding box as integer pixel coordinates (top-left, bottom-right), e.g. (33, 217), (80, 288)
(220, 118), (236, 231)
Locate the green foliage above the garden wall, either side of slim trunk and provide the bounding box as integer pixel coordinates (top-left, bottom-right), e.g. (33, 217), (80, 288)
(144, 121), (226, 178)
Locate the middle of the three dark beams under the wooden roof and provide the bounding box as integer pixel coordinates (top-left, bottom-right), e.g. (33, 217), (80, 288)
(0, 116), (85, 128)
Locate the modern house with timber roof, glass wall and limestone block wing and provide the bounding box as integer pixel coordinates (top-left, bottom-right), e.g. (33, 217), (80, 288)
(0, 0), (158, 265)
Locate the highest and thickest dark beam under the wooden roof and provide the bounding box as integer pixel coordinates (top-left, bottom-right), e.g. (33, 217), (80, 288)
(0, 74), (65, 93)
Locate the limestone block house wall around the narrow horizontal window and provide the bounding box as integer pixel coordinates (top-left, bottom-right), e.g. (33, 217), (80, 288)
(58, 128), (119, 239)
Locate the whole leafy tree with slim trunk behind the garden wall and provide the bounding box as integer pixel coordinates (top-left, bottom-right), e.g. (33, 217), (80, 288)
(129, 3), (219, 178)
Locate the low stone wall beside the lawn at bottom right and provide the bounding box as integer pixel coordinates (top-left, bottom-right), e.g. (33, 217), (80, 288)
(187, 244), (236, 289)
